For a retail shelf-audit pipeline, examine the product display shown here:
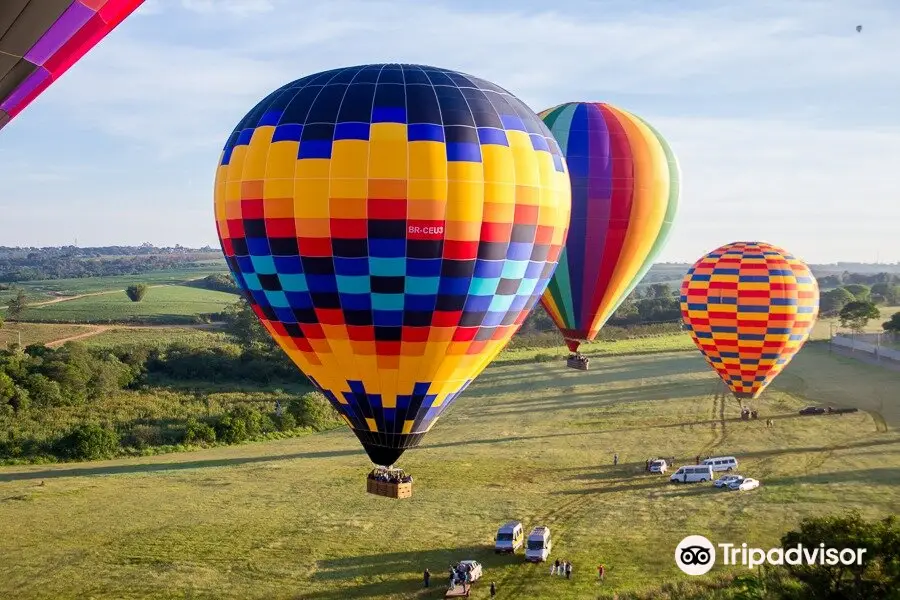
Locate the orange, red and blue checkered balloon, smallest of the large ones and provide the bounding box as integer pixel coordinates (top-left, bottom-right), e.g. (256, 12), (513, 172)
(681, 242), (819, 400)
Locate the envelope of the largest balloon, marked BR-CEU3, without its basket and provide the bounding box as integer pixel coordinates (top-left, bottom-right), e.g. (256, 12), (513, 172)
(215, 64), (570, 476)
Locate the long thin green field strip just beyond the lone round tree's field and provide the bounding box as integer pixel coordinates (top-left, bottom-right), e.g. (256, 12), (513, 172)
(0, 268), (227, 302)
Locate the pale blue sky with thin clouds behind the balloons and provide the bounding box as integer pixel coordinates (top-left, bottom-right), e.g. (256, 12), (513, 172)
(0, 0), (900, 263)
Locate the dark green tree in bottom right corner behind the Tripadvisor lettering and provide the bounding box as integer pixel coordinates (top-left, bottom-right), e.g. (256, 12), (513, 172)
(776, 512), (900, 600)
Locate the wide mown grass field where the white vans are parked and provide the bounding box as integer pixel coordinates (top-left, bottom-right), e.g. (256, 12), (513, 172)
(0, 342), (900, 600)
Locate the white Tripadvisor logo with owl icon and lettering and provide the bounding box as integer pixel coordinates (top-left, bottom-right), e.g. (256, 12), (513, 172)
(675, 535), (866, 575)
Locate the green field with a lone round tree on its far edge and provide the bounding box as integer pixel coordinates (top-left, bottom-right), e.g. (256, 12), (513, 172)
(15, 285), (237, 323)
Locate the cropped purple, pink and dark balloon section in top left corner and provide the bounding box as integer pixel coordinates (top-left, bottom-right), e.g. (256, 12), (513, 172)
(0, 0), (144, 129)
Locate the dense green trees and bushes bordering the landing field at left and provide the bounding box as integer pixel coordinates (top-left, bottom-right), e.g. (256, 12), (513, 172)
(0, 342), (339, 461)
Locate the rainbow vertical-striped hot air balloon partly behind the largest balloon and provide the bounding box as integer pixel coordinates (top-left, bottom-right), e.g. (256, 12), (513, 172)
(540, 102), (681, 366)
